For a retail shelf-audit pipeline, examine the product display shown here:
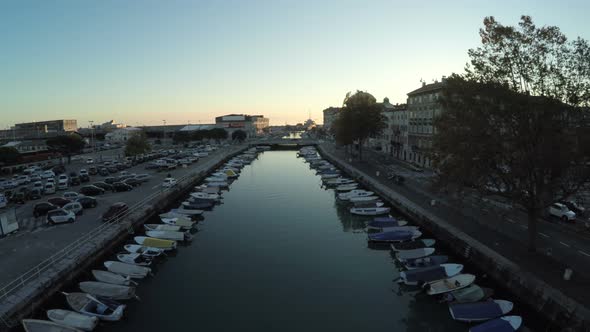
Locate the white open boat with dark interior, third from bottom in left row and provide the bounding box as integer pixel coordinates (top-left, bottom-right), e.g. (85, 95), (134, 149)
(63, 293), (126, 322)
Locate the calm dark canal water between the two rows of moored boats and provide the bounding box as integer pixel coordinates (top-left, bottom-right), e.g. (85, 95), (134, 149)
(108, 151), (468, 331)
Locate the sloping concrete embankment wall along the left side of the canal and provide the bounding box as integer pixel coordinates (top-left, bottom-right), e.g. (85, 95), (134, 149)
(0, 146), (247, 331)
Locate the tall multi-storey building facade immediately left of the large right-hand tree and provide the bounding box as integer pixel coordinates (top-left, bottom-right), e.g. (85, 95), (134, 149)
(407, 77), (445, 167)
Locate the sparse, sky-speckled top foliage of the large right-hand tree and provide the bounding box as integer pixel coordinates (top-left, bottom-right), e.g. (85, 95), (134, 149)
(466, 16), (590, 107)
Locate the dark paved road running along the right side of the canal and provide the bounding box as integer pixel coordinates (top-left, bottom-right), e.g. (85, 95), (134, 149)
(323, 144), (590, 304)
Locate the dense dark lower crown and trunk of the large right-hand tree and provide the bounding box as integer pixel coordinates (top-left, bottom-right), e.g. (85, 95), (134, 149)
(433, 75), (590, 251)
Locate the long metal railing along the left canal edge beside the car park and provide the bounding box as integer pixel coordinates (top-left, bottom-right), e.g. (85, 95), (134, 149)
(0, 147), (242, 327)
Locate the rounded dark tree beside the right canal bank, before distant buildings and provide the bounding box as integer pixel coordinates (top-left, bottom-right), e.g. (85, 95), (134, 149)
(334, 91), (387, 159)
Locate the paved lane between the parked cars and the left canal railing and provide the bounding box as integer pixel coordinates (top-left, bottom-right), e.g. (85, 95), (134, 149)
(0, 147), (243, 286)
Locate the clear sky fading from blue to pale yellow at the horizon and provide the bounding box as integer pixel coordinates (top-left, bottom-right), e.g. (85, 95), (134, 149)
(0, 0), (590, 129)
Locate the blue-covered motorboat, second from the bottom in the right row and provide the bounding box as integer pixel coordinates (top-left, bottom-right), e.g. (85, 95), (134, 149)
(449, 300), (514, 322)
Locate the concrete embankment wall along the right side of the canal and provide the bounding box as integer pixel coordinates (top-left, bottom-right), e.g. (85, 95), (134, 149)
(318, 146), (590, 331)
